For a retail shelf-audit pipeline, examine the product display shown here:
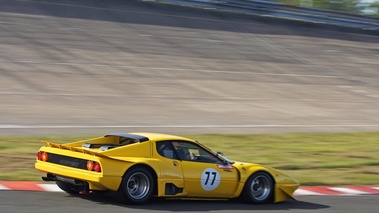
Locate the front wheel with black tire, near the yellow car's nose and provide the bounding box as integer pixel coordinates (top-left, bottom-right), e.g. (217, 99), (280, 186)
(241, 172), (274, 204)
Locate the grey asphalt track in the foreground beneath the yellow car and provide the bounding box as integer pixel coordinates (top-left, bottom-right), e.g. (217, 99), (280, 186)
(0, 191), (378, 213)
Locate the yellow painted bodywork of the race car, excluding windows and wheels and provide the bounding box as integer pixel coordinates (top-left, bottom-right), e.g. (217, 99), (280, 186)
(35, 133), (299, 202)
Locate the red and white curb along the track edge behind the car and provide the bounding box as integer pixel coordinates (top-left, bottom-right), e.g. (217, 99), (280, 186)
(0, 181), (379, 196)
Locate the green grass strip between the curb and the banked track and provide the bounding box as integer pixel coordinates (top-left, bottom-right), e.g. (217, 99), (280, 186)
(0, 132), (379, 185)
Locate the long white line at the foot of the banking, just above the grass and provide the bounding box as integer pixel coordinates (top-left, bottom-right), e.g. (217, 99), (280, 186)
(0, 124), (379, 129)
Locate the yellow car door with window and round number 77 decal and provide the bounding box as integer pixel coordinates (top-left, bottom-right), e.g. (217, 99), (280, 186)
(172, 141), (238, 198)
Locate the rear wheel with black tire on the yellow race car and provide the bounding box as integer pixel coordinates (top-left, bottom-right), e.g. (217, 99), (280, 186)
(118, 167), (155, 204)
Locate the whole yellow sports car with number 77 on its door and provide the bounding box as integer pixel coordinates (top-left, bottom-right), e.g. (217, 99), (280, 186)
(35, 133), (299, 204)
